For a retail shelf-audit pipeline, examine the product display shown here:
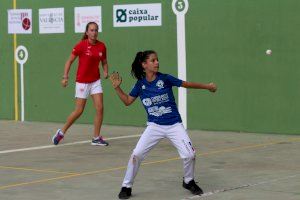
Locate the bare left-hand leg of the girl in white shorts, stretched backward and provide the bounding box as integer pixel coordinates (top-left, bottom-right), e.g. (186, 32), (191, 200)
(61, 98), (86, 134)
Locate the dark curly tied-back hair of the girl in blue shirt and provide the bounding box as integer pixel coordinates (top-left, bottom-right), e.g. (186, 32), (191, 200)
(131, 50), (156, 80)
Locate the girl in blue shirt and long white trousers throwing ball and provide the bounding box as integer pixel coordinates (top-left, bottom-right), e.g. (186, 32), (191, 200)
(110, 50), (217, 199)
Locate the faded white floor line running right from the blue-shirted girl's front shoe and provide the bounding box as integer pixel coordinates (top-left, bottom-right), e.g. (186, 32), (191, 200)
(182, 174), (300, 200)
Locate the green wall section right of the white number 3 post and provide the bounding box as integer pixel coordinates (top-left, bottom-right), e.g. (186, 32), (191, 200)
(186, 0), (300, 133)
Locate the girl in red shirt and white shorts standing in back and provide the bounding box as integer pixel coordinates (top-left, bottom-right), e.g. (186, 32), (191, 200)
(52, 22), (108, 146)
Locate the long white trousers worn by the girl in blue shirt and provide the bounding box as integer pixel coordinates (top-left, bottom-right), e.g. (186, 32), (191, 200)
(122, 123), (195, 188)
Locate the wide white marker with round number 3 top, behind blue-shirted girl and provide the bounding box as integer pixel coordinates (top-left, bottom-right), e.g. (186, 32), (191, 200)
(172, 0), (189, 129)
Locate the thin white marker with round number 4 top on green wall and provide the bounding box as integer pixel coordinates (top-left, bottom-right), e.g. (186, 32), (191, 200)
(15, 46), (28, 122)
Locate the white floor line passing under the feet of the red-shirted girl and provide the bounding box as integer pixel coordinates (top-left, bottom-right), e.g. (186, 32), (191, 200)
(0, 134), (141, 154)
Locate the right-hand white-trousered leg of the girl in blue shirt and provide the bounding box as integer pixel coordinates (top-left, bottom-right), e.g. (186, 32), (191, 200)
(167, 123), (195, 183)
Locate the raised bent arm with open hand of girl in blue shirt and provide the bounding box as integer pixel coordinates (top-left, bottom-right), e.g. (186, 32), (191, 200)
(109, 72), (136, 106)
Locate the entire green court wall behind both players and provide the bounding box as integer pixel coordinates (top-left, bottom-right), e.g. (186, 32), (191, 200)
(0, 0), (300, 133)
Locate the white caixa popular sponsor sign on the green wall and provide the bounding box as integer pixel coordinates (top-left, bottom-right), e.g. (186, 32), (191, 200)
(113, 3), (162, 27)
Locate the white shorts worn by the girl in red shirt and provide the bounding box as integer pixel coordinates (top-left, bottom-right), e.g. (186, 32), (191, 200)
(75, 79), (103, 99)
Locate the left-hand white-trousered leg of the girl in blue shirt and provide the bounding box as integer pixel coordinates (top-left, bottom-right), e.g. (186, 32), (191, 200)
(122, 124), (165, 188)
